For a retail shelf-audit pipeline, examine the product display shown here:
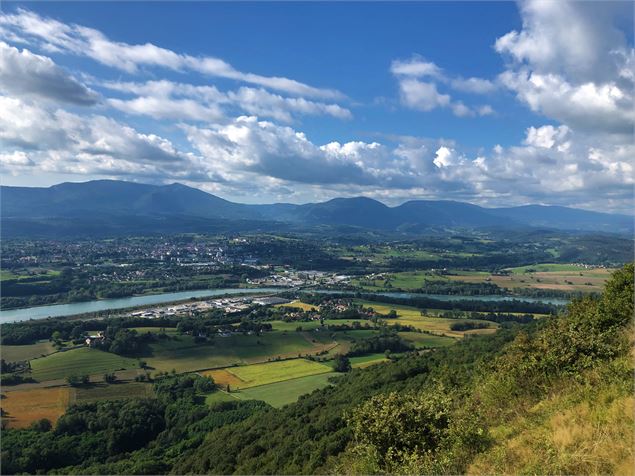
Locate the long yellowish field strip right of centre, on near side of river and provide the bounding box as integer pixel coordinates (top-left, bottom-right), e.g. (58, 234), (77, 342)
(355, 299), (498, 338)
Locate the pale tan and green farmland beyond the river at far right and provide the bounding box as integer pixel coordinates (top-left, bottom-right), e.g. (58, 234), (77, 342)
(448, 264), (614, 293)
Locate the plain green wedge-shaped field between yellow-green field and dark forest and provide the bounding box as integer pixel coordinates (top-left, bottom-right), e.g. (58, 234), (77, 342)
(229, 372), (340, 408)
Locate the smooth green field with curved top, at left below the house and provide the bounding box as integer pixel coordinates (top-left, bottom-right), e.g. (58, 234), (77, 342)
(31, 347), (138, 382)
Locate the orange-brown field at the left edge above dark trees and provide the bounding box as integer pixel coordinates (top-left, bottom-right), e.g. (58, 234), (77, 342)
(0, 387), (72, 428)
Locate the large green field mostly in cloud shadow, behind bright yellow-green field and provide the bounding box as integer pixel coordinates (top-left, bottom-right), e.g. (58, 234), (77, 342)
(144, 331), (333, 372)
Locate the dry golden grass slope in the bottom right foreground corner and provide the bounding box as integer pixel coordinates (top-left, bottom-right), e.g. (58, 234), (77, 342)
(467, 378), (635, 475)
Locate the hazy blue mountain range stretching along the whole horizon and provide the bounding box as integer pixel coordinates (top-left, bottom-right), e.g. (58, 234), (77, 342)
(0, 180), (633, 237)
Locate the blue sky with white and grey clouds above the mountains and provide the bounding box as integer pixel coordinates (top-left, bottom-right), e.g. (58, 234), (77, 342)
(0, 0), (635, 214)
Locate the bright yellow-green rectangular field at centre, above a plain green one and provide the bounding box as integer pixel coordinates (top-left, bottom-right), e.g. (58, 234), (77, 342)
(227, 359), (333, 389)
